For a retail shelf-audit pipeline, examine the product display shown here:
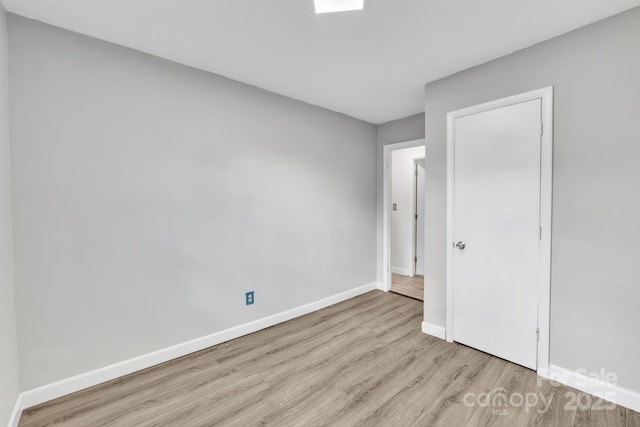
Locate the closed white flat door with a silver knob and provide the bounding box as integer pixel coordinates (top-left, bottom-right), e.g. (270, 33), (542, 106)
(452, 99), (541, 369)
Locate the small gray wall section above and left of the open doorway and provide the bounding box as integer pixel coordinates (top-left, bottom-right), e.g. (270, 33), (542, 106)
(376, 113), (424, 282)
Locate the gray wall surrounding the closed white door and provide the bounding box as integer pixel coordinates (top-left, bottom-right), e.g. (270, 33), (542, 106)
(425, 8), (640, 391)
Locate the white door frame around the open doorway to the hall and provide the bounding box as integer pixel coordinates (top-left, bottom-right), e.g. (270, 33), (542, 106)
(381, 138), (426, 292)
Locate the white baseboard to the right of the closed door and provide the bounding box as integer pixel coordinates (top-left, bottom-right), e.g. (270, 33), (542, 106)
(539, 364), (640, 412)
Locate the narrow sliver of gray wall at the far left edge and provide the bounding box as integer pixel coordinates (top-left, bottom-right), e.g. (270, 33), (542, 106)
(0, 5), (19, 425)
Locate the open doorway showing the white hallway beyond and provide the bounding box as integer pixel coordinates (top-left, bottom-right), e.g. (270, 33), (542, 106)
(385, 140), (425, 301)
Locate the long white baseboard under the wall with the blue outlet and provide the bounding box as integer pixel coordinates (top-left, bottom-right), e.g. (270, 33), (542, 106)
(15, 282), (378, 416)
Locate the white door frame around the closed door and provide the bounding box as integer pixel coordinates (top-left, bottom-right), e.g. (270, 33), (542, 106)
(446, 86), (553, 375)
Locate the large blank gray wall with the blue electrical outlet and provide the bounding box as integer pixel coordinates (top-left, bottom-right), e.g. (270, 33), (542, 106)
(9, 16), (376, 390)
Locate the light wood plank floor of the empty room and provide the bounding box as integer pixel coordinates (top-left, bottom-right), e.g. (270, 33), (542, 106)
(20, 291), (640, 427)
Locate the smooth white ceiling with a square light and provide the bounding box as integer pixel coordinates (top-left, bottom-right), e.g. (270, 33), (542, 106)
(2, 0), (640, 123)
